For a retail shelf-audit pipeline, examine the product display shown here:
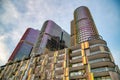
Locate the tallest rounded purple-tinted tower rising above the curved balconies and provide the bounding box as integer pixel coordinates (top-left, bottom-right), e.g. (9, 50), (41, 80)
(74, 6), (99, 43)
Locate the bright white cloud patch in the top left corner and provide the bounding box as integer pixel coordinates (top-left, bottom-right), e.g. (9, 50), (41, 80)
(0, 0), (20, 24)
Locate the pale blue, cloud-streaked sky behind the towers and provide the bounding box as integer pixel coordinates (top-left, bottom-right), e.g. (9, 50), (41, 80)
(0, 0), (120, 67)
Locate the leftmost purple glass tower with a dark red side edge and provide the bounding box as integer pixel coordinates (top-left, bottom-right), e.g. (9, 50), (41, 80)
(8, 28), (40, 61)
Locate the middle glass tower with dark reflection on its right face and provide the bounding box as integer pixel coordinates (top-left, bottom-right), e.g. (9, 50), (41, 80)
(33, 20), (70, 54)
